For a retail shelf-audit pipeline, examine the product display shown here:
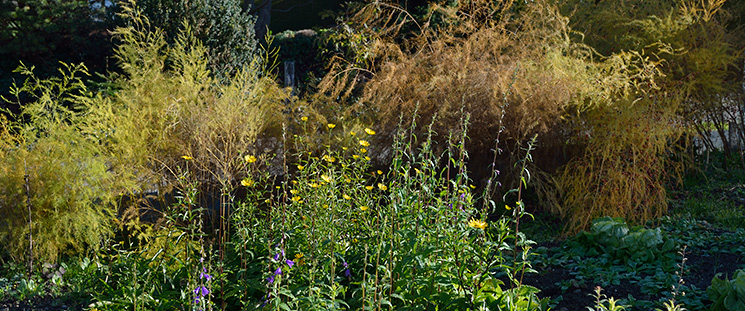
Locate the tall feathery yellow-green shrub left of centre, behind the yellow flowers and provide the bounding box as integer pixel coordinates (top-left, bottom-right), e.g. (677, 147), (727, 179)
(83, 4), (290, 207)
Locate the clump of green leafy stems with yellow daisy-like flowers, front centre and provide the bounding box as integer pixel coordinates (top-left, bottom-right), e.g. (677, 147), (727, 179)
(221, 114), (547, 310)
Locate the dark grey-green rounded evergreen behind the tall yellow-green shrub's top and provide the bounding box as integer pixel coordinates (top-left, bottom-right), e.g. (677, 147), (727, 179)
(136, 0), (261, 81)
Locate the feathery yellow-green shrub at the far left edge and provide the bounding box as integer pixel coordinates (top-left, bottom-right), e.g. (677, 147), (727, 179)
(0, 65), (120, 262)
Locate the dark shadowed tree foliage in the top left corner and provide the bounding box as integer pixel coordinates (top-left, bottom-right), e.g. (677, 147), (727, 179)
(0, 0), (113, 108)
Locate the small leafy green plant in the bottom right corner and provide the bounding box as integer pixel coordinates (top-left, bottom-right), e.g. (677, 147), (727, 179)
(706, 270), (745, 311)
